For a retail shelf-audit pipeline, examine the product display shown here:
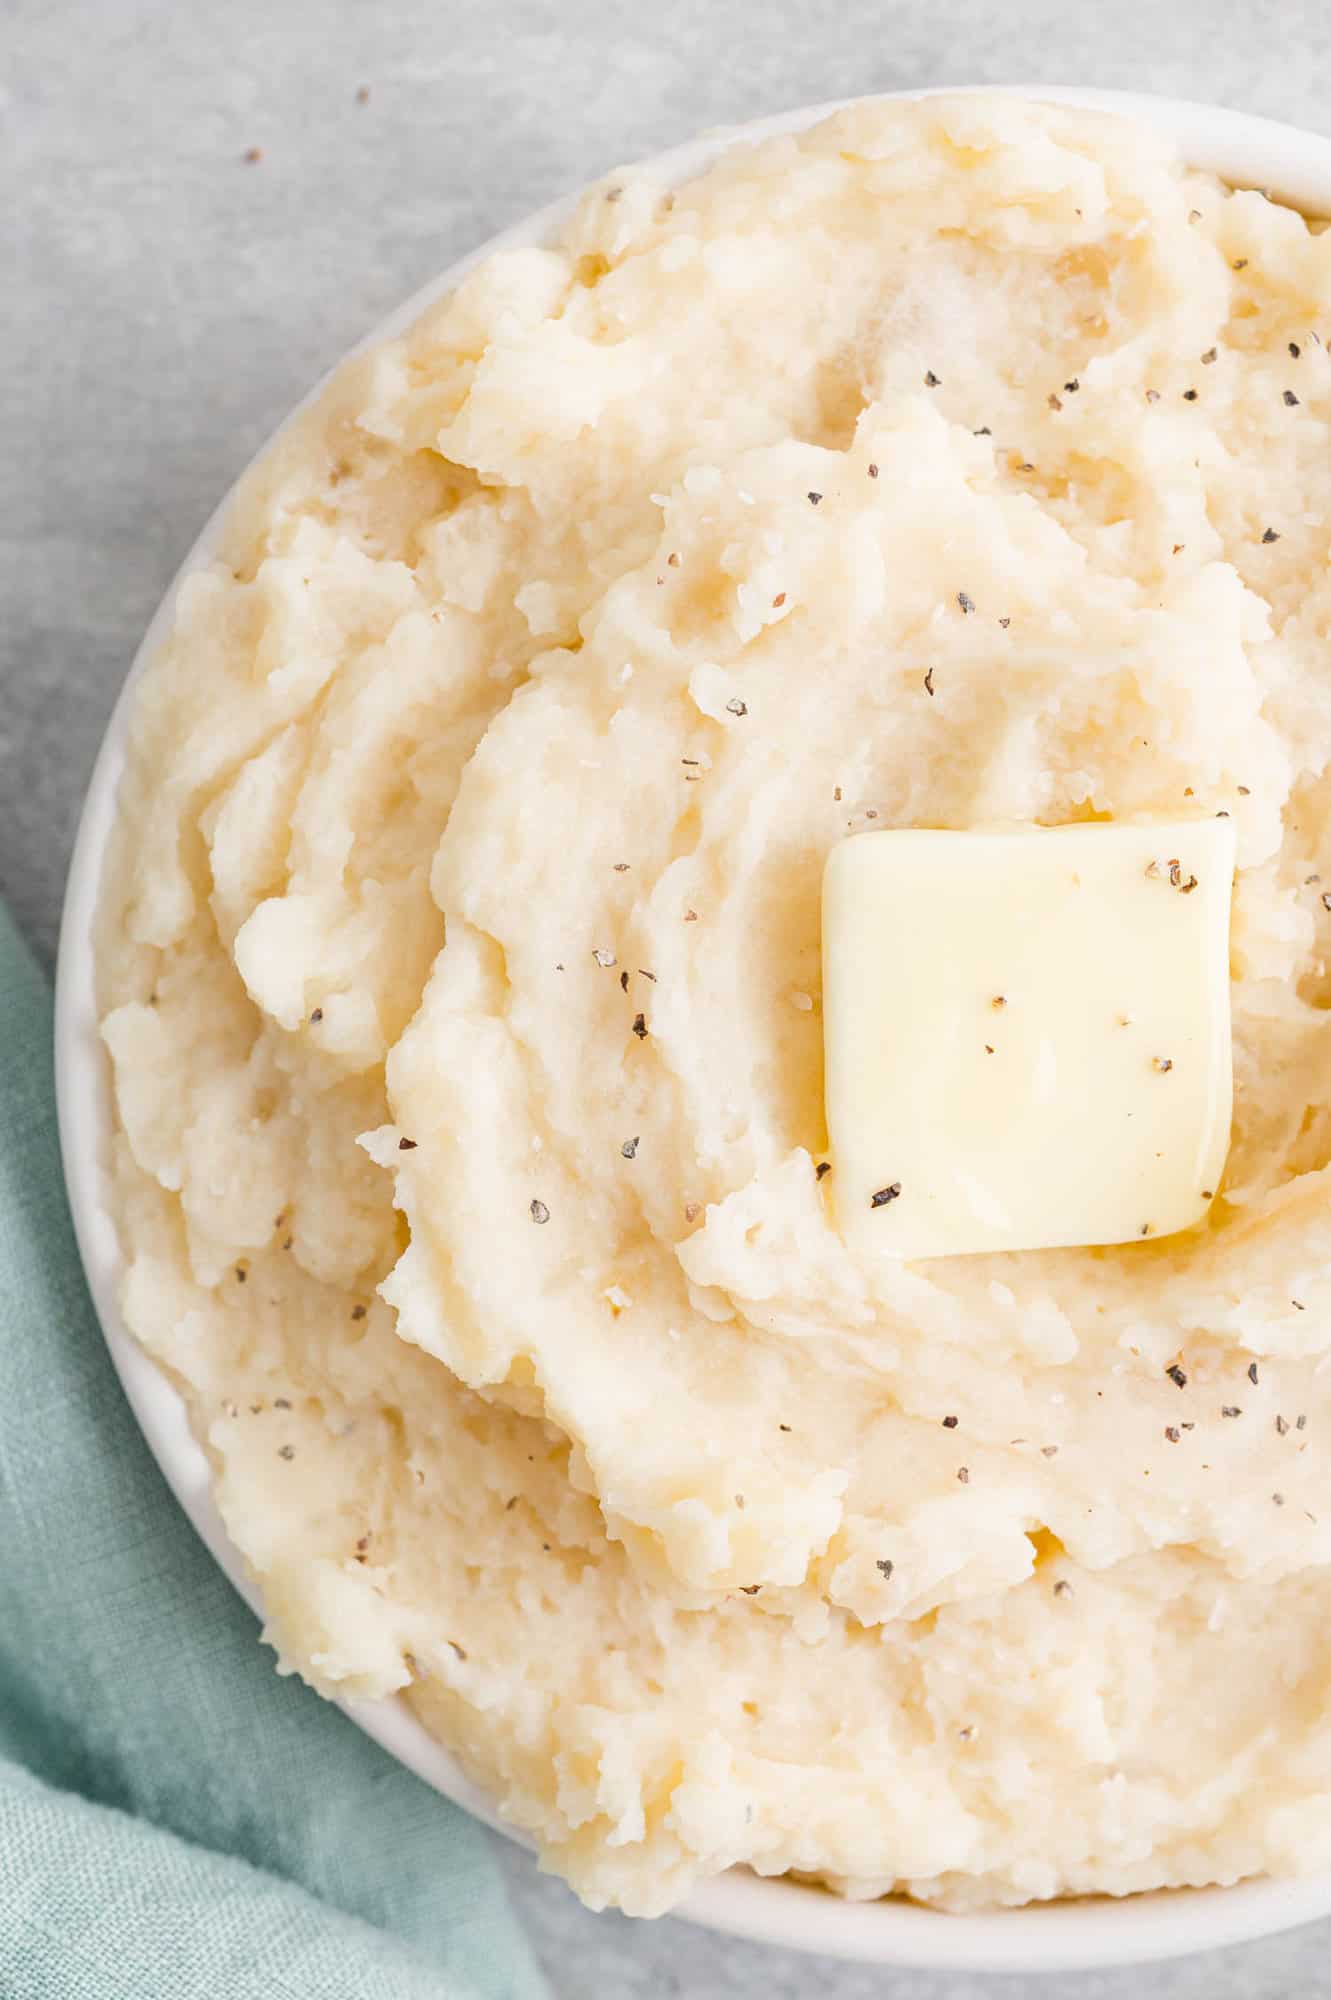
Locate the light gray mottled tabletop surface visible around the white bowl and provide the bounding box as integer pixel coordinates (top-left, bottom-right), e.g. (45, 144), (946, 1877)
(0, 0), (1331, 2000)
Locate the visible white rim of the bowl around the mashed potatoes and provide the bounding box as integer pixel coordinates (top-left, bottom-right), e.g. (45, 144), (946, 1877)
(56, 86), (1331, 1972)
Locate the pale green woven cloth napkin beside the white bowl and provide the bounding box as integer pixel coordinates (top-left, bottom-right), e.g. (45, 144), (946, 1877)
(0, 906), (544, 2000)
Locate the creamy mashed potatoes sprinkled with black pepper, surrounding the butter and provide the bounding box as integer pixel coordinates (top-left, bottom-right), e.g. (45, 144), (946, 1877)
(100, 98), (1331, 1912)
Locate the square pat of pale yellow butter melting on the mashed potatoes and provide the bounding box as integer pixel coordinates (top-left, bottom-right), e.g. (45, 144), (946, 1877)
(823, 818), (1235, 1258)
